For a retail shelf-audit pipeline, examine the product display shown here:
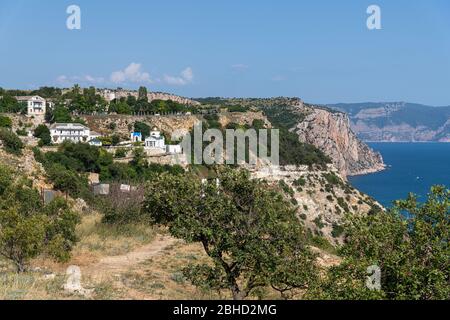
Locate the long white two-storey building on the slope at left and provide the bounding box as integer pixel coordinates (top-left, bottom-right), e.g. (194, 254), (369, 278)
(50, 123), (100, 144)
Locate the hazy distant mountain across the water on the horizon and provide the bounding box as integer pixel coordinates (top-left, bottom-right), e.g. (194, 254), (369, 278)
(327, 102), (450, 142)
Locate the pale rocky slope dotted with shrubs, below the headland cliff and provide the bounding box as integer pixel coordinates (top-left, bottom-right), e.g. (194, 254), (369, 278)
(252, 165), (383, 244)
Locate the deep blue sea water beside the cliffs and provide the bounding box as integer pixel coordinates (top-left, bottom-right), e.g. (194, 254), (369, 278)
(349, 143), (450, 207)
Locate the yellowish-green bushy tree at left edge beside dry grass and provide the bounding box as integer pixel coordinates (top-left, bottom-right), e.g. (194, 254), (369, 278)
(0, 168), (80, 272)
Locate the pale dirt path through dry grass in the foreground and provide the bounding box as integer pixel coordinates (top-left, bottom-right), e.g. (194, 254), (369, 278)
(82, 236), (179, 280)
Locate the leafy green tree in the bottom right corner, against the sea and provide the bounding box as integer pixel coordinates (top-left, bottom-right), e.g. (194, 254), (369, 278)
(315, 186), (450, 300)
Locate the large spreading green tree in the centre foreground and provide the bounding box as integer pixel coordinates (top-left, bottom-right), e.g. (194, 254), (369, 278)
(143, 169), (317, 299)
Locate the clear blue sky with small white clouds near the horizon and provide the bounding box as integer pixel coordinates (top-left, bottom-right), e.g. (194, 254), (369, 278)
(0, 0), (450, 105)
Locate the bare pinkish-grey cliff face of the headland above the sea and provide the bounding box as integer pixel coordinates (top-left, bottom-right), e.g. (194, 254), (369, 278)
(292, 105), (385, 176)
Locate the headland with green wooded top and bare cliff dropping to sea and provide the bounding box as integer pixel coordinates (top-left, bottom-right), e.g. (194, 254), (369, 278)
(197, 97), (385, 177)
